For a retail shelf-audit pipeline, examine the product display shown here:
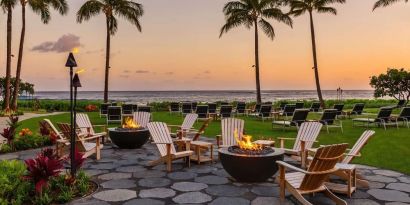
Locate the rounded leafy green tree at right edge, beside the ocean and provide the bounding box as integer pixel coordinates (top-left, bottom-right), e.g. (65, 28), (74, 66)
(370, 68), (410, 102)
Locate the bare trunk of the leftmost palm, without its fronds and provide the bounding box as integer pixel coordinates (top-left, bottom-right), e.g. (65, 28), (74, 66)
(4, 6), (13, 112)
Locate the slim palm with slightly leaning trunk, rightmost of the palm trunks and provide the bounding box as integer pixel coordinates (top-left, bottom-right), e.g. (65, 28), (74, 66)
(289, 0), (346, 108)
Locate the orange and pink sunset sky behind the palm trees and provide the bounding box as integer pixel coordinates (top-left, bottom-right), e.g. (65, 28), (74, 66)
(0, 0), (410, 91)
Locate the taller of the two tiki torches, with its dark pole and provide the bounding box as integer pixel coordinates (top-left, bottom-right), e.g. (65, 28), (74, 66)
(65, 52), (77, 176)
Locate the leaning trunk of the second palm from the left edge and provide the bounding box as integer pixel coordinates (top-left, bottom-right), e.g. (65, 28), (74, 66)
(12, 0), (26, 110)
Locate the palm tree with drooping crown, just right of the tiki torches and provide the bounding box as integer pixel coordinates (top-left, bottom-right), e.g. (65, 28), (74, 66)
(77, 0), (144, 102)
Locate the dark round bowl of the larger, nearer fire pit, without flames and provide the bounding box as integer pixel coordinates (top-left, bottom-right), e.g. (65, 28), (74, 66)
(218, 147), (284, 182)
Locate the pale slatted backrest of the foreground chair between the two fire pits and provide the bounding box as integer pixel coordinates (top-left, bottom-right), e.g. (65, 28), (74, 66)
(147, 122), (176, 157)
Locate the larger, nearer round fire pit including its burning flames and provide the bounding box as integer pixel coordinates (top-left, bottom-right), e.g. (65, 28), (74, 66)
(218, 133), (284, 182)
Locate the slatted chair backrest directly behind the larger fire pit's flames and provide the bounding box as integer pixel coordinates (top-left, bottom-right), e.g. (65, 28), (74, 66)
(221, 118), (245, 146)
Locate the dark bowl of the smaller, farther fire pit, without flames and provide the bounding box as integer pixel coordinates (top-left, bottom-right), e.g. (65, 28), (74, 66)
(108, 128), (150, 149)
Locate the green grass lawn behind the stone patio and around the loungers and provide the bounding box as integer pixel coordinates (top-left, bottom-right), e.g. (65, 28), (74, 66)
(20, 109), (410, 174)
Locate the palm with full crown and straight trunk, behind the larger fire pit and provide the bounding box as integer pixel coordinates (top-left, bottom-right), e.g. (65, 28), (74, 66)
(219, 0), (292, 103)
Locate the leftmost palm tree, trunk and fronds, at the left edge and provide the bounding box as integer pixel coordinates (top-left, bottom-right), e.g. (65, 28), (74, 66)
(0, 0), (17, 113)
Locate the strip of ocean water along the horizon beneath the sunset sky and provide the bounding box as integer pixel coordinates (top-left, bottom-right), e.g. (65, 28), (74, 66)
(34, 90), (373, 103)
